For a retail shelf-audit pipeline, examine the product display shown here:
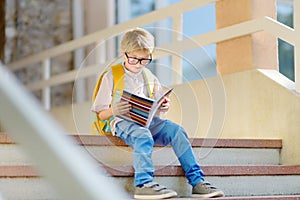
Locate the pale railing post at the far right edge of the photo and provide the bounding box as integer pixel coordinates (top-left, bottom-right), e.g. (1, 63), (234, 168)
(294, 0), (300, 93)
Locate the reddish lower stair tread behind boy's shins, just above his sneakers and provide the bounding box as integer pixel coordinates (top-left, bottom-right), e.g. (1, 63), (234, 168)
(0, 165), (300, 178)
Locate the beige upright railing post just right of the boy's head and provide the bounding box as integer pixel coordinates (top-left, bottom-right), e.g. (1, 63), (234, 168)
(172, 13), (183, 84)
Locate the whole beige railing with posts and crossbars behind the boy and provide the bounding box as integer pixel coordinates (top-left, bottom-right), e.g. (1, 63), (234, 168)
(8, 0), (300, 109)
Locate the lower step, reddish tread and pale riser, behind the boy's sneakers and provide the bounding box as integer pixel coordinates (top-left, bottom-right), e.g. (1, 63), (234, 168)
(0, 165), (300, 199)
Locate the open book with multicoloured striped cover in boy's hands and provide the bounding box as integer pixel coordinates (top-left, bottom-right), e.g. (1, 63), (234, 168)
(118, 88), (173, 127)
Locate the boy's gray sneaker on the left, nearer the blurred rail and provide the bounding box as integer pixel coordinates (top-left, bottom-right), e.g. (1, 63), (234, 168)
(134, 182), (177, 199)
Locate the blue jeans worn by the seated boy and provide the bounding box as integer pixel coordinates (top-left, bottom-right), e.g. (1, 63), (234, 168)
(116, 118), (204, 186)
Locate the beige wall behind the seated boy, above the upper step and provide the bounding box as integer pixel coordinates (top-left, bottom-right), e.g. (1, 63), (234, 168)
(51, 70), (300, 164)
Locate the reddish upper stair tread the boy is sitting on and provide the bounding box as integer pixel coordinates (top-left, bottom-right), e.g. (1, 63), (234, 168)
(0, 132), (282, 149)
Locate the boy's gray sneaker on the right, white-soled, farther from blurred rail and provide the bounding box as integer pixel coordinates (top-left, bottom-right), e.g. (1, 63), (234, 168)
(192, 181), (225, 198)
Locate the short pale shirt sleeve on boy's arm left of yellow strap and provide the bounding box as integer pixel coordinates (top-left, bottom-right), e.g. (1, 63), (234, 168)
(91, 71), (113, 113)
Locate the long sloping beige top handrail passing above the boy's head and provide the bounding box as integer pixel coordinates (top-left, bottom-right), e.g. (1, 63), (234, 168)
(8, 0), (219, 71)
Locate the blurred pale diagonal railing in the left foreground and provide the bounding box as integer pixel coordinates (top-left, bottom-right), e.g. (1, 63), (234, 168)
(0, 63), (129, 200)
